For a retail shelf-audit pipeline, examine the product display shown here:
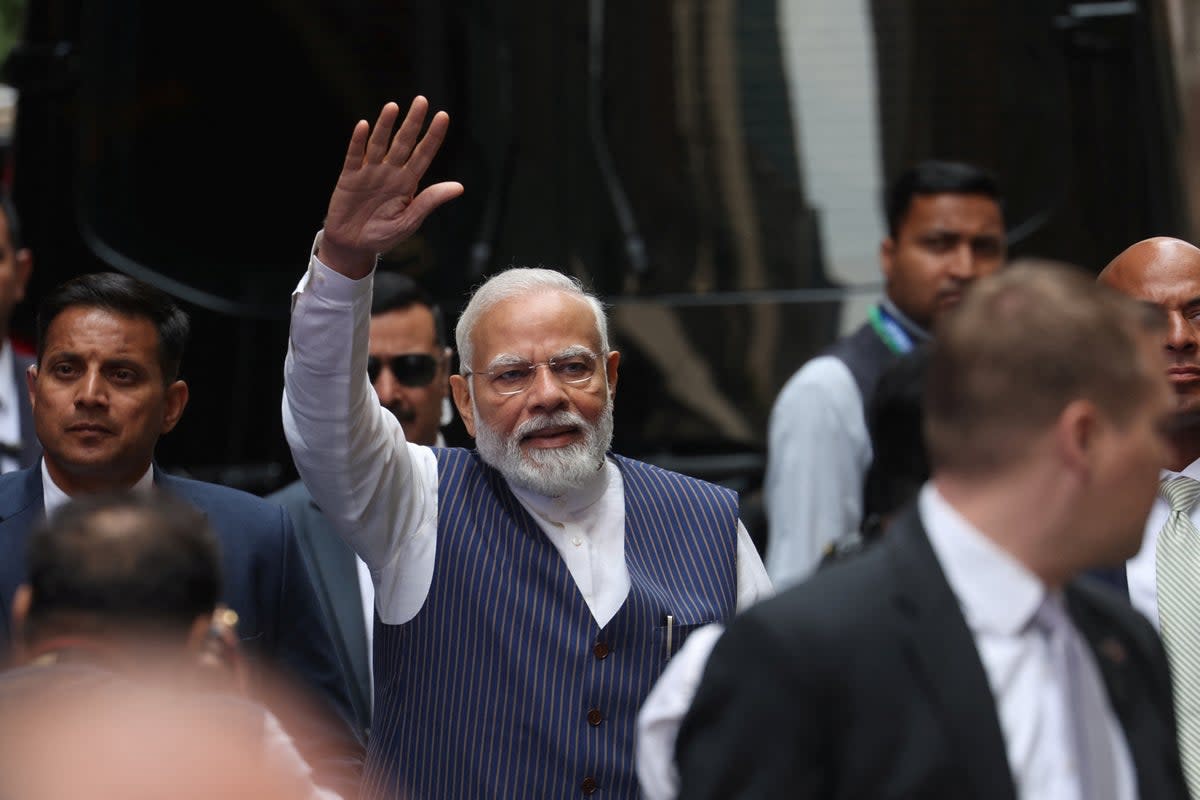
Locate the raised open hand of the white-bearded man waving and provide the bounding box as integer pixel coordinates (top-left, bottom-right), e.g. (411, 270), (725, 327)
(319, 96), (462, 279)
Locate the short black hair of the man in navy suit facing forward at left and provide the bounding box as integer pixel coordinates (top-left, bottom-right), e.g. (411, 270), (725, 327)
(37, 272), (191, 384)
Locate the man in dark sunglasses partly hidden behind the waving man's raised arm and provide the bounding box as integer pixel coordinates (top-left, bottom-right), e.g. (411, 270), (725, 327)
(266, 271), (454, 741)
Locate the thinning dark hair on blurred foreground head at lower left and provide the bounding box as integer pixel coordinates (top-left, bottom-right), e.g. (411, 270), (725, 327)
(25, 488), (222, 642)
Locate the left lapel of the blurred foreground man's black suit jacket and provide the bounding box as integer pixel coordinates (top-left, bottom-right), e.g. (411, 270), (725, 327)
(883, 506), (1016, 800)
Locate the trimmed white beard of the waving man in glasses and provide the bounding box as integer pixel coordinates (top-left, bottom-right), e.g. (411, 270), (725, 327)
(474, 398), (612, 498)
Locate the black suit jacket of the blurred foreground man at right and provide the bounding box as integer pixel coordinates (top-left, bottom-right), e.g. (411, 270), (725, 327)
(677, 507), (1188, 800)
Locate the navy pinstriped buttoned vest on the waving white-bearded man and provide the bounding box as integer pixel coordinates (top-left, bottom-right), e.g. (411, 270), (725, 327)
(362, 449), (737, 800)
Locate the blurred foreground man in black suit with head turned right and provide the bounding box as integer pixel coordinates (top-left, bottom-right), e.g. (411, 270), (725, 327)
(676, 264), (1188, 800)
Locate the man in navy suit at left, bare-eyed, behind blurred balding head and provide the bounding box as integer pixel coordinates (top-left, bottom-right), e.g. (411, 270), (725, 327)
(0, 272), (362, 789)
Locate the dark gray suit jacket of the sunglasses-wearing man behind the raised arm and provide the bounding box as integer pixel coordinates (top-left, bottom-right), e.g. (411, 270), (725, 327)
(266, 481), (371, 740)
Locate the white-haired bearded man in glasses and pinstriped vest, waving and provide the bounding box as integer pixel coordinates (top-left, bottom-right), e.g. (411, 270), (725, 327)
(283, 97), (772, 800)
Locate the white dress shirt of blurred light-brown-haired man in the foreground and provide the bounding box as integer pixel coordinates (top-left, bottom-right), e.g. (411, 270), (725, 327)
(918, 483), (1138, 800)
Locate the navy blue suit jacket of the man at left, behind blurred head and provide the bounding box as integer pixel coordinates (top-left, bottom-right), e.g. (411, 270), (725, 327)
(0, 461), (362, 788)
